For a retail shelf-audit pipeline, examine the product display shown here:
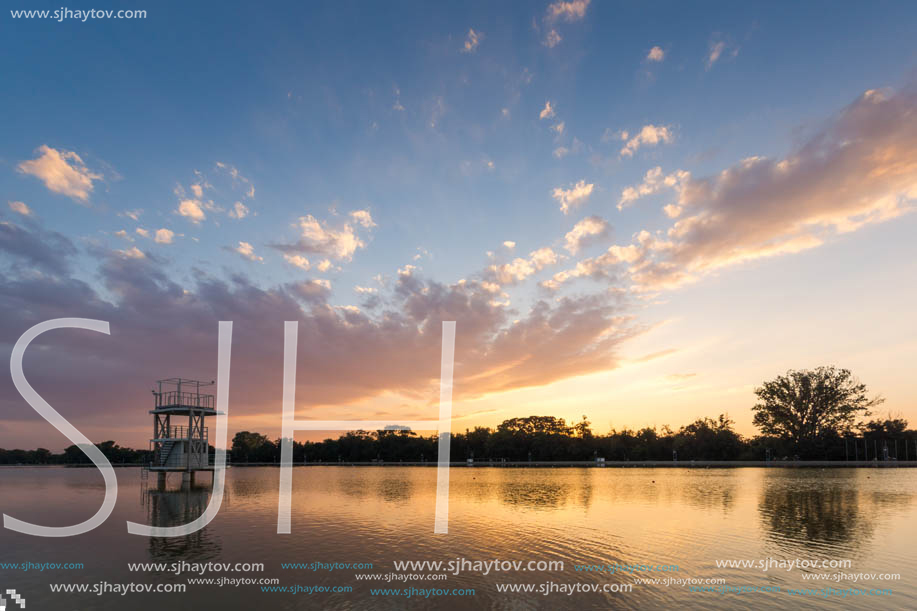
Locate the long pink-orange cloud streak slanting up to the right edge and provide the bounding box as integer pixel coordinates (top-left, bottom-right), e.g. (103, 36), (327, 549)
(552, 89), (917, 290)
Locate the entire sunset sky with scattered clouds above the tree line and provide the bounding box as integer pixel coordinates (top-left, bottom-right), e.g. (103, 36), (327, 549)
(0, 0), (917, 449)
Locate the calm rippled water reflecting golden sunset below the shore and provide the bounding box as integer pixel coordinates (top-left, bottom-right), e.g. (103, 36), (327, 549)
(0, 467), (917, 609)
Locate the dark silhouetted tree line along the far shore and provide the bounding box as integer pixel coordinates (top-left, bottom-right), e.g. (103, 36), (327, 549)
(0, 367), (917, 464)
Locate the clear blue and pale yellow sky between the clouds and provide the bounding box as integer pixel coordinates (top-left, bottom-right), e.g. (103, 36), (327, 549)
(0, 1), (917, 450)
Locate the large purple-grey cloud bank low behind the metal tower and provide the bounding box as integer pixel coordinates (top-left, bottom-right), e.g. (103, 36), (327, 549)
(0, 230), (640, 445)
